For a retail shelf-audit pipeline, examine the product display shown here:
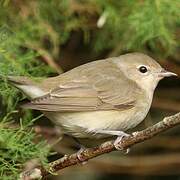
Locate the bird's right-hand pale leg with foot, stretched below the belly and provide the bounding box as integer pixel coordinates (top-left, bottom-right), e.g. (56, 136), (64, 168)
(95, 130), (130, 153)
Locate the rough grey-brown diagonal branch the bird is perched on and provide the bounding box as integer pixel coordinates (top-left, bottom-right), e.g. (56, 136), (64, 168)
(20, 113), (180, 180)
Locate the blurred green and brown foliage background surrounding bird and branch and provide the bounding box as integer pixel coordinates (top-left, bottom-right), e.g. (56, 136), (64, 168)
(0, 0), (180, 180)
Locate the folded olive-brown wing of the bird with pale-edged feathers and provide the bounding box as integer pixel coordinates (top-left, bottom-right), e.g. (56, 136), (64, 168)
(24, 62), (138, 112)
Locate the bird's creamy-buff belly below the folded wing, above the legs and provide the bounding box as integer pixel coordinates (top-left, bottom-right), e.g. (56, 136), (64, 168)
(45, 108), (147, 138)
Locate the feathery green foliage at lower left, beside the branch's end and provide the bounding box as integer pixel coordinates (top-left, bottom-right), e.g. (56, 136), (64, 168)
(0, 112), (49, 180)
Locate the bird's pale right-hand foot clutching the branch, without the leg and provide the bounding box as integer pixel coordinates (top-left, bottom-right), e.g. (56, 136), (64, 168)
(114, 131), (130, 154)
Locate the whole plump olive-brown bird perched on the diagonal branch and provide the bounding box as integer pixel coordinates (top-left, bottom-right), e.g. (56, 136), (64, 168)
(8, 53), (176, 148)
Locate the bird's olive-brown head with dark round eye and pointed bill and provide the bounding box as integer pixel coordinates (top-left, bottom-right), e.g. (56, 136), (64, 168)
(113, 53), (177, 91)
